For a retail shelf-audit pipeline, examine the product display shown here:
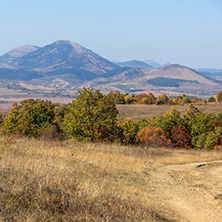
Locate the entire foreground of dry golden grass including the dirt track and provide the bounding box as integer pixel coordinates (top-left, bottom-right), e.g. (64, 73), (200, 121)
(0, 137), (222, 222)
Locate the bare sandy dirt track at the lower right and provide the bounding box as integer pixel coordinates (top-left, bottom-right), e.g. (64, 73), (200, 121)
(147, 161), (222, 222)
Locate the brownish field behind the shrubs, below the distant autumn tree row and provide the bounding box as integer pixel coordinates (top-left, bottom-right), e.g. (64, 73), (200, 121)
(117, 103), (222, 120)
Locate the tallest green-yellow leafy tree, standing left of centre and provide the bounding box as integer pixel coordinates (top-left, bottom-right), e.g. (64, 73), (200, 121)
(64, 88), (118, 142)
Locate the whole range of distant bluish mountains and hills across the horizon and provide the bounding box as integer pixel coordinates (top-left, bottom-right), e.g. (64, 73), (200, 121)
(0, 40), (221, 95)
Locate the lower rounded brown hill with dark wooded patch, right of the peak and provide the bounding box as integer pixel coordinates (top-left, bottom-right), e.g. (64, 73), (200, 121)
(84, 64), (221, 95)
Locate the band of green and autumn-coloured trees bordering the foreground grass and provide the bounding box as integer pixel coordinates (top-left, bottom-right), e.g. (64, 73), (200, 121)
(0, 88), (222, 150)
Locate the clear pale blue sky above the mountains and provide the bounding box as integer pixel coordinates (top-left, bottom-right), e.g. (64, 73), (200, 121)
(0, 0), (222, 68)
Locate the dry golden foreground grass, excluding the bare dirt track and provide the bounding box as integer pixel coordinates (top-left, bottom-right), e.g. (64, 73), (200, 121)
(0, 138), (222, 221)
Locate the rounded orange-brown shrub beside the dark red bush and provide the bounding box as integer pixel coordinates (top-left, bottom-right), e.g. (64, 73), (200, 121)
(136, 126), (171, 147)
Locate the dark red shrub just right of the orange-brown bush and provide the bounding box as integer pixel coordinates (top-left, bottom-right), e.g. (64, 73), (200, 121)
(171, 126), (191, 148)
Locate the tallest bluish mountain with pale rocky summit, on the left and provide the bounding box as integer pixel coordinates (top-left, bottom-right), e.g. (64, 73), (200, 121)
(0, 40), (119, 80)
